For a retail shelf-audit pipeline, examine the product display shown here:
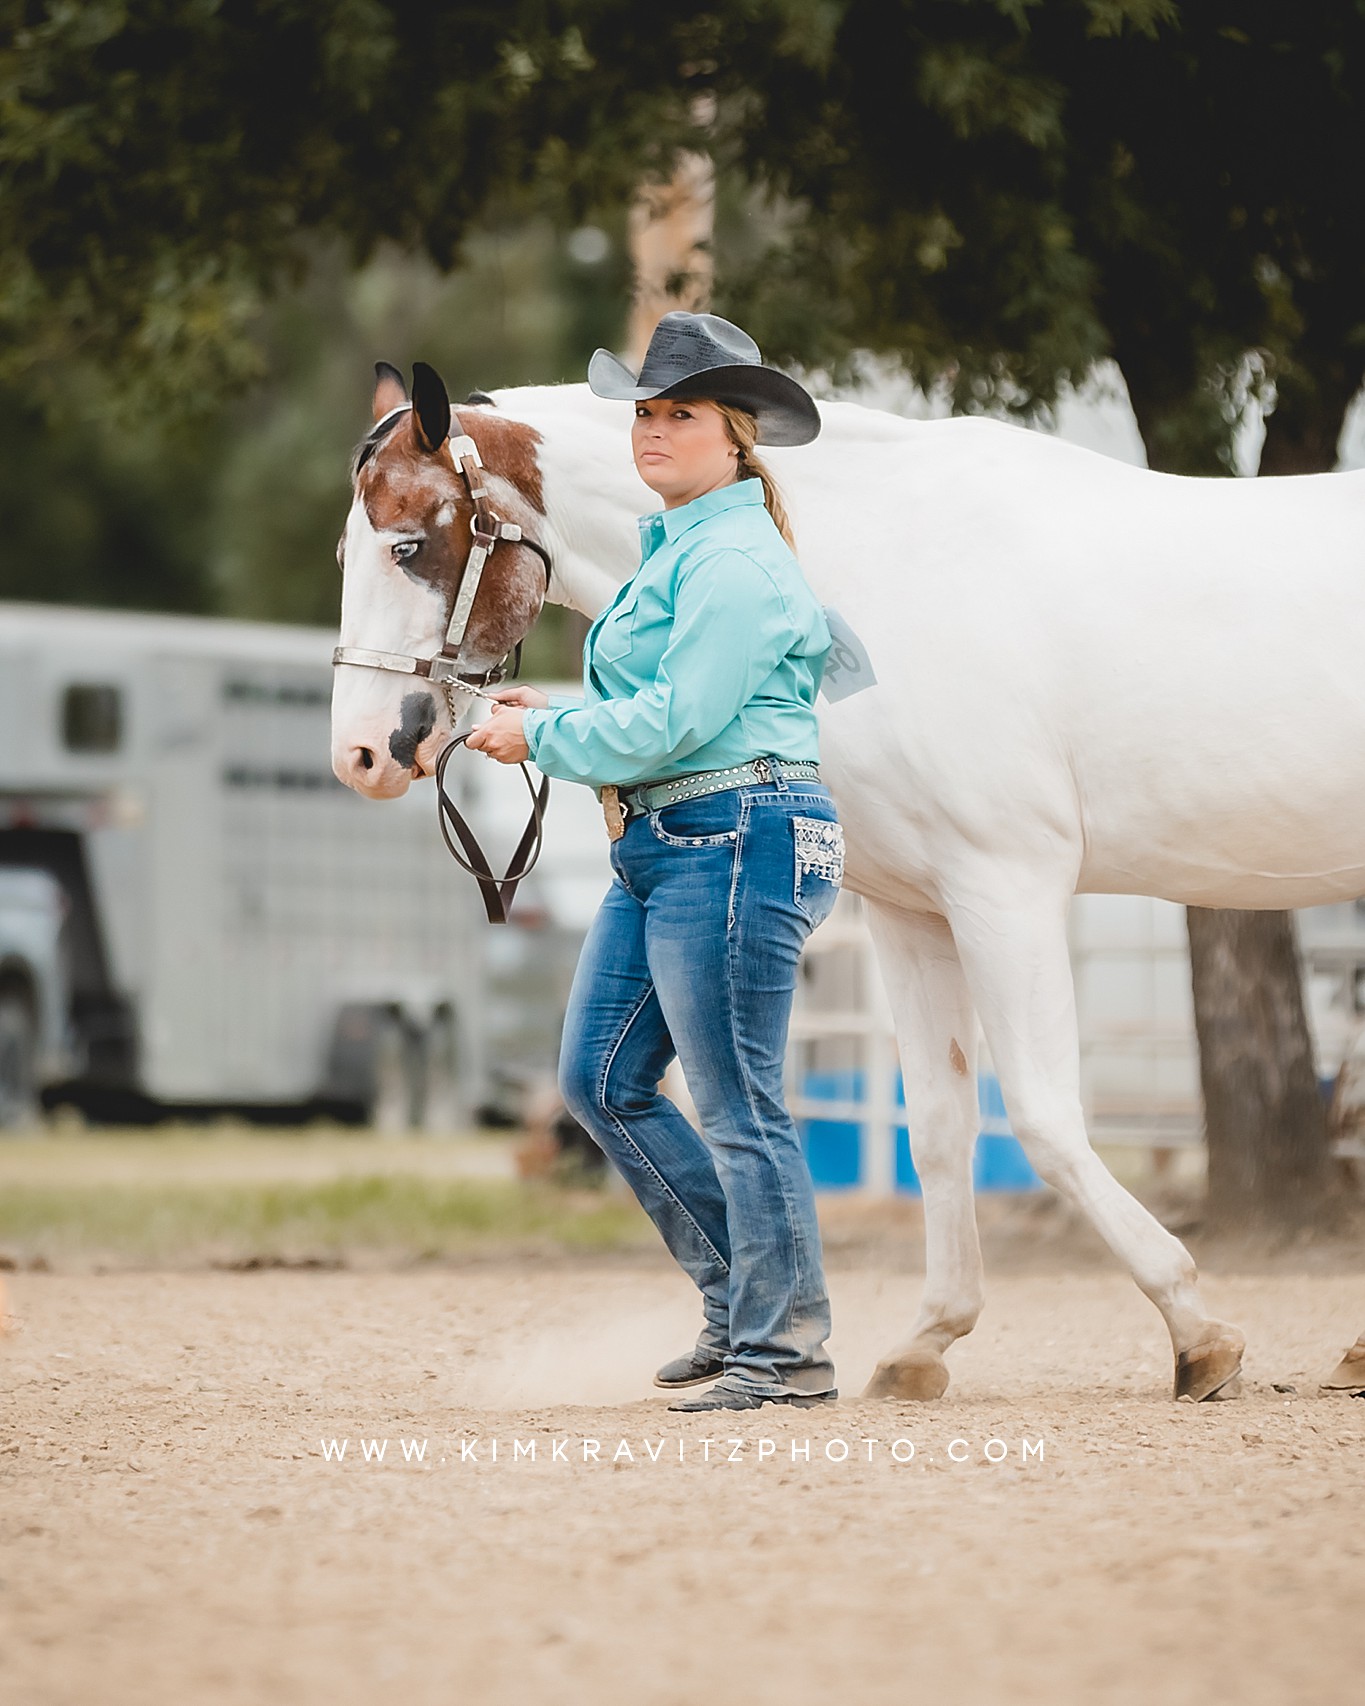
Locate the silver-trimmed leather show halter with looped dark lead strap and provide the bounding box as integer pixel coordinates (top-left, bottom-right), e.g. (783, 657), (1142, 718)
(331, 403), (553, 925)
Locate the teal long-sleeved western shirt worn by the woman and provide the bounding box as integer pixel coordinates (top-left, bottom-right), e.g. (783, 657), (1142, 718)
(524, 479), (829, 786)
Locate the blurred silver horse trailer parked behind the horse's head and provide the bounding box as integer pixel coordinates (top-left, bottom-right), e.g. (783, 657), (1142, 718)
(0, 604), (498, 1128)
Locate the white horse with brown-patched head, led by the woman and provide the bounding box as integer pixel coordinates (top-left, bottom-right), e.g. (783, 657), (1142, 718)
(333, 367), (1365, 1401)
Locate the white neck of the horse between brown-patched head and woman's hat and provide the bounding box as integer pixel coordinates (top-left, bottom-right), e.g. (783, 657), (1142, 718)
(498, 386), (657, 616)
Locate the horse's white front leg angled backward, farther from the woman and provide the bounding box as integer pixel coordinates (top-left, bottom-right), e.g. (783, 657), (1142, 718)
(949, 872), (1246, 1399)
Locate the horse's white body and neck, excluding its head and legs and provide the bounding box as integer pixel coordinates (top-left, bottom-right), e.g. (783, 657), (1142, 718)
(518, 387), (1365, 908)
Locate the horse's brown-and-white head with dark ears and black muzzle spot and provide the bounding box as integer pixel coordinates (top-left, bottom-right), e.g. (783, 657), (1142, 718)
(331, 362), (546, 800)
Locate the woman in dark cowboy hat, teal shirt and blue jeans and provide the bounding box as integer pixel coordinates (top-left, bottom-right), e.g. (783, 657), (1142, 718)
(469, 314), (843, 1411)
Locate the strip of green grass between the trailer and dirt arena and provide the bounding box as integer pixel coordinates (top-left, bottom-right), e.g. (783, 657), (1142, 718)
(0, 1174), (650, 1261)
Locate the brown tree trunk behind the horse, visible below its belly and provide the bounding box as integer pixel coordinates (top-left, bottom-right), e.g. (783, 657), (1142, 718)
(1124, 375), (1341, 1230)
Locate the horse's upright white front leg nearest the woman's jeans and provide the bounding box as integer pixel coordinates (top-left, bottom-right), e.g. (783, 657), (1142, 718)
(863, 902), (981, 1399)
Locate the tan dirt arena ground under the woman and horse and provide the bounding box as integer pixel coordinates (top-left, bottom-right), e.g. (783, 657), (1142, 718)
(0, 1257), (1365, 1706)
